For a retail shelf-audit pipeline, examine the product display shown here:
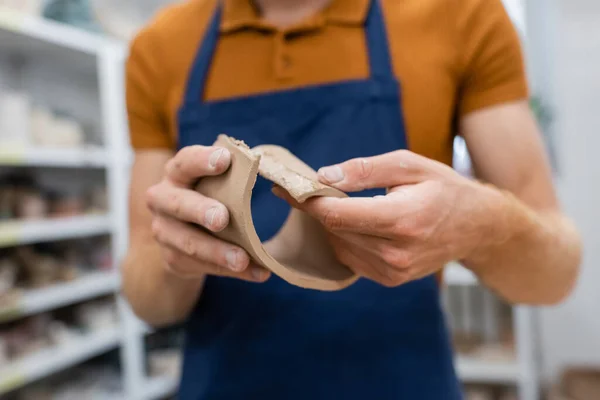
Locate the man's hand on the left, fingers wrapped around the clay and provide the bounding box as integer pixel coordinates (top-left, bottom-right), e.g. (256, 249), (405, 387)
(147, 146), (270, 282)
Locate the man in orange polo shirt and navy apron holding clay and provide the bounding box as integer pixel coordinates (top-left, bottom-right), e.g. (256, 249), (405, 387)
(124, 0), (580, 400)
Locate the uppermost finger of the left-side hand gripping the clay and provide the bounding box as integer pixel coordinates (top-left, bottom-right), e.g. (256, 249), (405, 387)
(166, 146), (231, 187)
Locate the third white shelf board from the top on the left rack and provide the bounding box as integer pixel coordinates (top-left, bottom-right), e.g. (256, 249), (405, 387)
(0, 215), (111, 248)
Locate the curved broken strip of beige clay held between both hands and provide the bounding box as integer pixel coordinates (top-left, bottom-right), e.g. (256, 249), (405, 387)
(196, 135), (358, 291)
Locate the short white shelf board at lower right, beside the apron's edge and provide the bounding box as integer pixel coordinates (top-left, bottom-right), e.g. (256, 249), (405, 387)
(456, 356), (520, 384)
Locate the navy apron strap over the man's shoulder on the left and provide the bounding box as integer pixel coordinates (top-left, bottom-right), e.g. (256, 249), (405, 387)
(185, 2), (221, 103)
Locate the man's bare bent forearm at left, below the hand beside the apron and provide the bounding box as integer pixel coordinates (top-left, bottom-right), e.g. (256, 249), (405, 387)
(123, 239), (204, 326)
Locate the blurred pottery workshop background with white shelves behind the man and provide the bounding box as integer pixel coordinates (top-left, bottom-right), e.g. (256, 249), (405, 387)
(0, 0), (600, 400)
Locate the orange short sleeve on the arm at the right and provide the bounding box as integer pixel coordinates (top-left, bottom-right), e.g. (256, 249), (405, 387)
(458, 0), (529, 116)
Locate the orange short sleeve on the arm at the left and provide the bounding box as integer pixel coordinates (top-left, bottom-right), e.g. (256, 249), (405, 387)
(126, 28), (174, 150)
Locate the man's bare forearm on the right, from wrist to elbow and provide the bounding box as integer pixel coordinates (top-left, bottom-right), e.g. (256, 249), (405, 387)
(463, 187), (581, 305)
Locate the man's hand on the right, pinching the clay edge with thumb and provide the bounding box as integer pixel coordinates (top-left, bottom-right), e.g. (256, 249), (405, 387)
(274, 150), (500, 287)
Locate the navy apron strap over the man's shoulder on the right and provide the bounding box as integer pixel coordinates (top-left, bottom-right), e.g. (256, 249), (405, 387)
(365, 0), (395, 80)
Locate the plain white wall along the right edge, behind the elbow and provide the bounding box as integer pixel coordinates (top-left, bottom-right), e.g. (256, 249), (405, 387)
(527, 0), (600, 378)
